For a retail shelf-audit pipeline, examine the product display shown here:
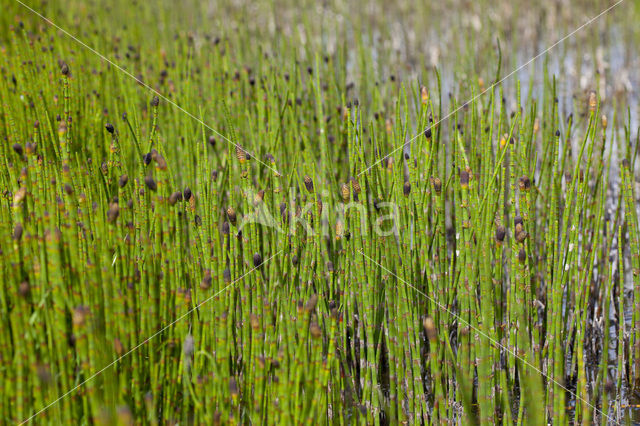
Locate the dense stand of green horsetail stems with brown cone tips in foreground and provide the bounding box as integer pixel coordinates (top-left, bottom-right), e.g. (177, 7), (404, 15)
(0, 1), (640, 424)
